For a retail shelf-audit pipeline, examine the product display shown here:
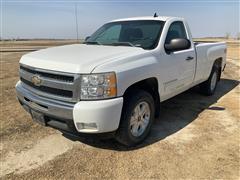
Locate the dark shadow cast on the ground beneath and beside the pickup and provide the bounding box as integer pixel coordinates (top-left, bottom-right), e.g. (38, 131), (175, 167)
(64, 79), (239, 151)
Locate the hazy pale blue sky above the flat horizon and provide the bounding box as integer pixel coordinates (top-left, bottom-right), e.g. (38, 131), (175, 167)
(1, 0), (239, 39)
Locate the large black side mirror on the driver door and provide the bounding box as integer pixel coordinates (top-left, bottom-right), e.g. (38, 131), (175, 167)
(164, 38), (191, 52)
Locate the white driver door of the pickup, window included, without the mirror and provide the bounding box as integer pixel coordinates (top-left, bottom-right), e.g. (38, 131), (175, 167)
(163, 21), (196, 96)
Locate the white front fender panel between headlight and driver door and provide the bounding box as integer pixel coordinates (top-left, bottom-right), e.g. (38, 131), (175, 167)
(94, 53), (160, 96)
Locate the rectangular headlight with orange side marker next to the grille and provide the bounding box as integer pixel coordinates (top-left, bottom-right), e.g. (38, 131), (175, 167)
(81, 72), (117, 100)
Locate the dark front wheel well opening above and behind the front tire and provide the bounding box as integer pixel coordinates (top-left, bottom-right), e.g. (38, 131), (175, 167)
(123, 77), (160, 117)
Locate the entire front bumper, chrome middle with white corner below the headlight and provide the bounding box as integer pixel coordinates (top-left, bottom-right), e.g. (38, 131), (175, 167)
(16, 81), (123, 134)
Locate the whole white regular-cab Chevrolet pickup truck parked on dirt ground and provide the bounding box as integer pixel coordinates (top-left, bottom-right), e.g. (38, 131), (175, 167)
(16, 16), (226, 146)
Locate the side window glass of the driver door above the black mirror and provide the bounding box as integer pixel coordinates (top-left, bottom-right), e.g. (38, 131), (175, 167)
(165, 21), (187, 44)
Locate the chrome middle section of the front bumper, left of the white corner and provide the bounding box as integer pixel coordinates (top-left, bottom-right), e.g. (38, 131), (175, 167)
(16, 81), (74, 120)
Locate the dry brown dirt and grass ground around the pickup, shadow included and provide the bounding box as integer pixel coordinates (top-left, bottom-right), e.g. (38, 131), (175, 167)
(0, 41), (240, 179)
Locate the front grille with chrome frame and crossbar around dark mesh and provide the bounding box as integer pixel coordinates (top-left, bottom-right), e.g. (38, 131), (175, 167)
(19, 65), (80, 102)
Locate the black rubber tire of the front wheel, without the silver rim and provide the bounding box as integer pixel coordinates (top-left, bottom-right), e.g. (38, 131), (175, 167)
(116, 90), (155, 147)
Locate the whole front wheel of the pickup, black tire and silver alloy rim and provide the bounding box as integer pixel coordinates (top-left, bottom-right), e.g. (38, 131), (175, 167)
(116, 90), (155, 146)
